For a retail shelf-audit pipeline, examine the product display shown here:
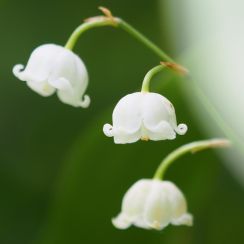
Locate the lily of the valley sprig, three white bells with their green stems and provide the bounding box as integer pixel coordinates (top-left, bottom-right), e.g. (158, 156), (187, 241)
(13, 7), (232, 233)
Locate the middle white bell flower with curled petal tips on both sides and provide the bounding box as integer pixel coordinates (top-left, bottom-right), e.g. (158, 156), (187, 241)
(103, 92), (187, 144)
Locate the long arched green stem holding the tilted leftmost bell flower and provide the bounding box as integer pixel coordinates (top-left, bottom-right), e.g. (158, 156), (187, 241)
(65, 16), (174, 62)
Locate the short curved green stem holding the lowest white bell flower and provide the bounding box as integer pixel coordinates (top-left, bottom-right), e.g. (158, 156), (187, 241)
(153, 139), (230, 180)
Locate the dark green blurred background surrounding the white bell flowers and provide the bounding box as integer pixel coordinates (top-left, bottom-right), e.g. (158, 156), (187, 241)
(0, 0), (244, 244)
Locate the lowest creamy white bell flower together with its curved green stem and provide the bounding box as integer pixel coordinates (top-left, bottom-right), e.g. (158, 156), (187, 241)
(112, 139), (229, 230)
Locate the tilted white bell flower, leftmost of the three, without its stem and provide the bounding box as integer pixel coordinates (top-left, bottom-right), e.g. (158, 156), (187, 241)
(13, 44), (90, 107)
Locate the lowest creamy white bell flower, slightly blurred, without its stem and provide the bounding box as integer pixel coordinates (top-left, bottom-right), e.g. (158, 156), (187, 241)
(112, 179), (193, 230)
